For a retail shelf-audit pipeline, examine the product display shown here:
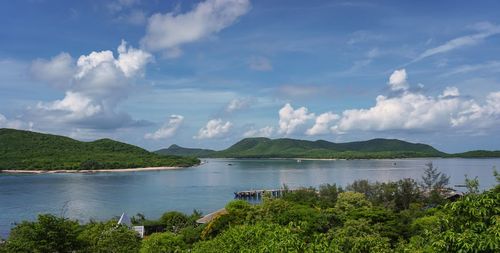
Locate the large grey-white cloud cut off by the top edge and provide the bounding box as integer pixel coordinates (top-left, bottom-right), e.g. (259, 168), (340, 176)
(141, 0), (250, 55)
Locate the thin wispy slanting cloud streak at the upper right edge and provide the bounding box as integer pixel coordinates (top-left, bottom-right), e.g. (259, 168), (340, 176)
(412, 23), (500, 62)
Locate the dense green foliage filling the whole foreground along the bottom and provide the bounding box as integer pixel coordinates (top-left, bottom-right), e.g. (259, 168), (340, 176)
(0, 165), (500, 253)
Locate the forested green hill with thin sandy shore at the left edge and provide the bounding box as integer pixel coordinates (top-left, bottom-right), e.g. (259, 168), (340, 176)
(0, 128), (199, 170)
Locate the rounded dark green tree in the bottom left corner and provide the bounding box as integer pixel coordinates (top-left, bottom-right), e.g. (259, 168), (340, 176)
(5, 214), (81, 252)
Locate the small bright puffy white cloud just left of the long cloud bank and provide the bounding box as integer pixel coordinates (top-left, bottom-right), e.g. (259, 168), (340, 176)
(278, 103), (314, 135)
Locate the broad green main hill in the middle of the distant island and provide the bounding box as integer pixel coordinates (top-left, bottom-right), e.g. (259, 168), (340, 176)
(212, 138), (446, 159)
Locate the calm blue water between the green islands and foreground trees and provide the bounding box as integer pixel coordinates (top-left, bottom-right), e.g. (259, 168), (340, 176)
(0, 159), (500, 238)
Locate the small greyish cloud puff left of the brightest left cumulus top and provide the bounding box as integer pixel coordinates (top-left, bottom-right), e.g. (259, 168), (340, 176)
(31, 53), (75, 88)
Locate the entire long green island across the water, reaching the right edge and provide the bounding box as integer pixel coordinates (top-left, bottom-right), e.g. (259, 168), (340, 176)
(155, 137), (500, 159)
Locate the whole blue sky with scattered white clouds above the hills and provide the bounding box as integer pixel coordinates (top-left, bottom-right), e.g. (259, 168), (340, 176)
(0, 0), (500, 152)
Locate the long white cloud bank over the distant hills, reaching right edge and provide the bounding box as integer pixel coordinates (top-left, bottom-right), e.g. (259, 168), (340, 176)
(332, 87), (500, 132)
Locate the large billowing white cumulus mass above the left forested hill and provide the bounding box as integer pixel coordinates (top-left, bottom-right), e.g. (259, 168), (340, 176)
(31, 41), (152, 129)
